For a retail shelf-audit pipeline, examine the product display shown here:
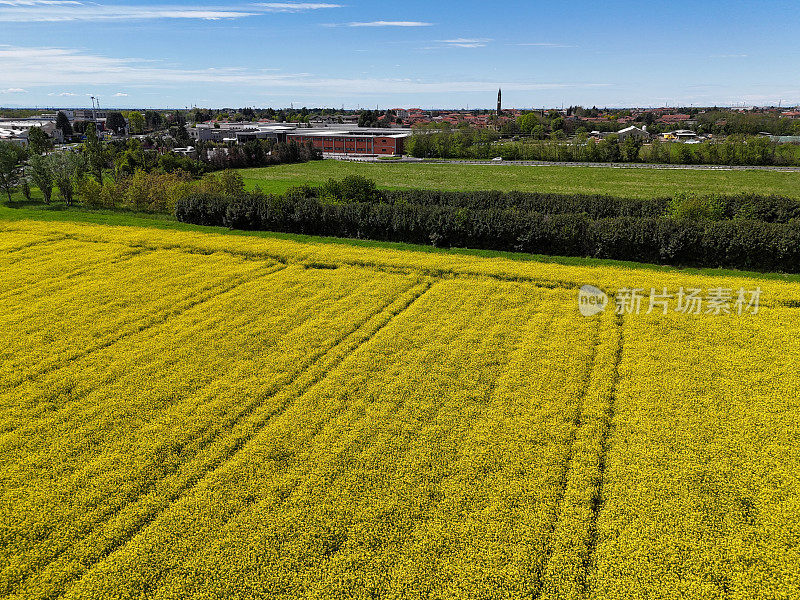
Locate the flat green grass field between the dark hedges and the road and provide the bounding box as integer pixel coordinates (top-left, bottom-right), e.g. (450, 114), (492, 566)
(241, 160), (800, 198)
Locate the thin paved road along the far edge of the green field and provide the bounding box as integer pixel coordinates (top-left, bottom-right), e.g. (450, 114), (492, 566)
(325, 154), (800, 173)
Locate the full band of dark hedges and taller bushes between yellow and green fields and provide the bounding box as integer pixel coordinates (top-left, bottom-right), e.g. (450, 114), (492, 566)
(176, 176), (800, 273)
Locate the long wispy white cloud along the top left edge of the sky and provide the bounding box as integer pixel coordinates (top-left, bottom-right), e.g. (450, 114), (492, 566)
(0, 0), (342, 23)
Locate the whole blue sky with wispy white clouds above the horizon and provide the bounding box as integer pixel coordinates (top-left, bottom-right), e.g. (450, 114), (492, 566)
(0, 0), (800, 108)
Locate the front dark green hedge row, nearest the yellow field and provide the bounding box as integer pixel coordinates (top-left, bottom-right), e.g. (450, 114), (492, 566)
(176, 194), (800, 273)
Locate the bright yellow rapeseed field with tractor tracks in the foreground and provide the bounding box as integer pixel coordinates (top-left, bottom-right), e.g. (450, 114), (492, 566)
(0, 221), (800, 600)
